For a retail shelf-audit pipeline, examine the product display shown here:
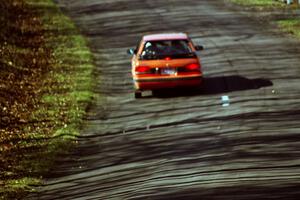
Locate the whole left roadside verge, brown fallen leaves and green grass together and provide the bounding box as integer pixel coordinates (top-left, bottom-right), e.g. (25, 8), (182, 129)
(0, 0), (93, 199)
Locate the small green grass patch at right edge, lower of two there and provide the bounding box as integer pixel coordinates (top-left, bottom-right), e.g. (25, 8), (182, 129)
(277, 19), (300, 39)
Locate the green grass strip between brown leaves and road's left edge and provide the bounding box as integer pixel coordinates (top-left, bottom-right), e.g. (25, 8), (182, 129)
(0, 0), (94, 199)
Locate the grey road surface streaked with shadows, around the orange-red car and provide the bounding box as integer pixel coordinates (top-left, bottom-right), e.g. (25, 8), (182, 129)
(31, 0), (300, 200)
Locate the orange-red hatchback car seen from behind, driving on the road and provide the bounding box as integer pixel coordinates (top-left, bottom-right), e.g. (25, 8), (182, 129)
(127, 33), (203, 98)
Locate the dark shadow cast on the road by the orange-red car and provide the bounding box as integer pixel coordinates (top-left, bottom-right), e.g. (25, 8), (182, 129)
(153, 76), (273, 98)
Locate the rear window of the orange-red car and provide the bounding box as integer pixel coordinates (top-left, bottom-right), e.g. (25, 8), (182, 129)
(140, 40), (196, 60)
